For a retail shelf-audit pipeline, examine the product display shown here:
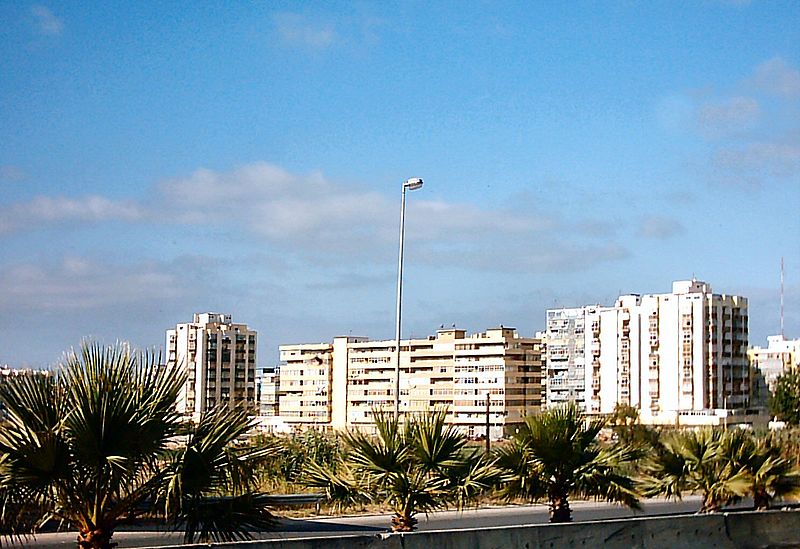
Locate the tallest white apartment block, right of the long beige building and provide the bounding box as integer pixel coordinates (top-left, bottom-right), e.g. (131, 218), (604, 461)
(547, 280), (750, 424)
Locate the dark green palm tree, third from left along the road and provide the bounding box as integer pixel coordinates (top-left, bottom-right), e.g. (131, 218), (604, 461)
(497, 404), (639, 522)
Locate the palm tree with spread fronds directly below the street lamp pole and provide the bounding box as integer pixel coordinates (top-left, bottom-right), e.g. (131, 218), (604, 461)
(304, 409), (497, 532)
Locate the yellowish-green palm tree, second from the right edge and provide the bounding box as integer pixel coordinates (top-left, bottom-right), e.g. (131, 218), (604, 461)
(642, 429), (750, 513)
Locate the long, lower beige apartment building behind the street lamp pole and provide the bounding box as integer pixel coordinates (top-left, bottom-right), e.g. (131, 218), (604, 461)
(280, 327), (543, 438)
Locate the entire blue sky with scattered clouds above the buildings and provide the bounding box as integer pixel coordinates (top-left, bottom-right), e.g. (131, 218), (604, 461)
(0, 0), (800, 366)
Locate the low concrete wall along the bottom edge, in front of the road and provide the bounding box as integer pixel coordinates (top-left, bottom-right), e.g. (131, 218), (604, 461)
(159, 510), (800, 549)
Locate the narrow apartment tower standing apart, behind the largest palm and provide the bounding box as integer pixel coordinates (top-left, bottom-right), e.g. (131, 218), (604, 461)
(166, 313), (257, 415)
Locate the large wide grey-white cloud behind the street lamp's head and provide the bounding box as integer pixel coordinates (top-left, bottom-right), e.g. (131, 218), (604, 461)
(159, 163), (625, 271)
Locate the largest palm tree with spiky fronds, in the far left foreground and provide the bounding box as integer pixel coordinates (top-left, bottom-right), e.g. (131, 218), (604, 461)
(0, 343), (270, 549)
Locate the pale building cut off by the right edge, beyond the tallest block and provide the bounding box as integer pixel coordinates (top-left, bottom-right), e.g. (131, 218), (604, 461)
(747, 335), (800, 406)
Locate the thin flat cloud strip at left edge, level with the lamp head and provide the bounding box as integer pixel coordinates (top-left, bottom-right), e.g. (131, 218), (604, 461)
(0, 196), (143, 234)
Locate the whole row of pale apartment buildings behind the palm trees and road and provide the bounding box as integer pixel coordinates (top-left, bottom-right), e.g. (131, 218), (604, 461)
(166, 280), (800, 438)
